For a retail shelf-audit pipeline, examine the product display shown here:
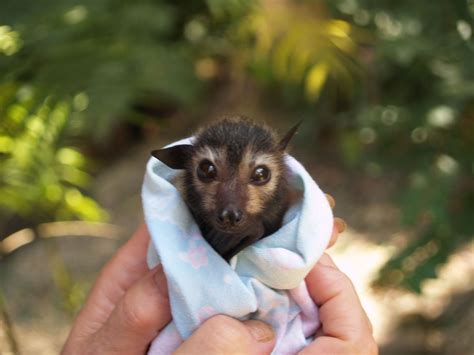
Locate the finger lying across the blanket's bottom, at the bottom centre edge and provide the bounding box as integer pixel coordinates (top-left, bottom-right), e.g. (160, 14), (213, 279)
(174, 315), (275, 355)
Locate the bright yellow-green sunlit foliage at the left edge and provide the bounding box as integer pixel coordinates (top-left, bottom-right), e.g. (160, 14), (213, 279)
(0, 85), (106, 223)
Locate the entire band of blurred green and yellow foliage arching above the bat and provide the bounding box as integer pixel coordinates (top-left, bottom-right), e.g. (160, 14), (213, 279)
(0, 0), (474, 291)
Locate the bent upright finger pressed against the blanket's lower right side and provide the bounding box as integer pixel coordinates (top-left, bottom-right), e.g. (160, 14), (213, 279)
(306, 254), (371, 344)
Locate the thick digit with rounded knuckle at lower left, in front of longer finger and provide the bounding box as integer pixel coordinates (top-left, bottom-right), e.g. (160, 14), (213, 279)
(88, 266), (171, 355)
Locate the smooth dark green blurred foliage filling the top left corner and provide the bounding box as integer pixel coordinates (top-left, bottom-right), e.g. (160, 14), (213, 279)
(0, 0), (209, 138)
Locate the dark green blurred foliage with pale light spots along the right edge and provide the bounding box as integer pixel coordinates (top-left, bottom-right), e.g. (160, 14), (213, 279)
(324, 0), (474, 291)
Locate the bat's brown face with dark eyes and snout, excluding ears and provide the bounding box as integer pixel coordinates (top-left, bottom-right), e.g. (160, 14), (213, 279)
(187, 139), (283, 233)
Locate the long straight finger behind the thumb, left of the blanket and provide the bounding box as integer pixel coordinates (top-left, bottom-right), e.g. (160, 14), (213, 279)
(76, 224), (150, 333)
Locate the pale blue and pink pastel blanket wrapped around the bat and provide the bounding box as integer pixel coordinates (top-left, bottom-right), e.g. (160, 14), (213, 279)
(142, 139), (333, 355)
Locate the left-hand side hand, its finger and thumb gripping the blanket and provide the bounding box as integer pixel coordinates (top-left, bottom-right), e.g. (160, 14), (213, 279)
(62, 225), (171, 355)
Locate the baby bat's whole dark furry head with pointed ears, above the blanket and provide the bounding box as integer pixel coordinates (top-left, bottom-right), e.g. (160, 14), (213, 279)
(151, 117), (299, 260)
